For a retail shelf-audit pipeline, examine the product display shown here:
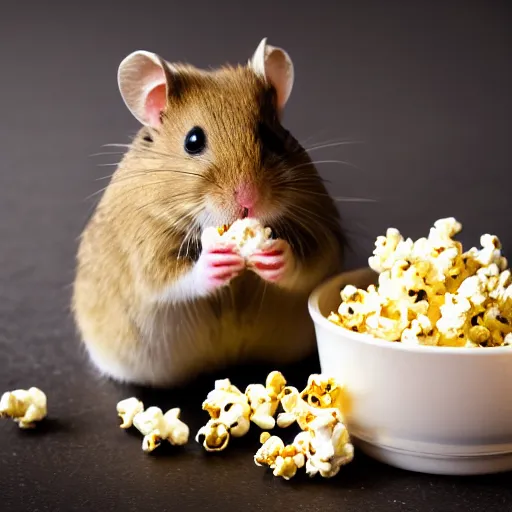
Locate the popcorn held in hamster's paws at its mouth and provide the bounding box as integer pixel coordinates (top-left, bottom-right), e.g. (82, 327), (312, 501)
(203, 217), (272, 258)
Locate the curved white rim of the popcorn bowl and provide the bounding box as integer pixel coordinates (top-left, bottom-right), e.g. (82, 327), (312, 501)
(308, 267), (512, 357)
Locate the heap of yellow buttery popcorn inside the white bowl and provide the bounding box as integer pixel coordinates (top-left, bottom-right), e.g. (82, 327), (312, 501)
(328, 217), (512, 347)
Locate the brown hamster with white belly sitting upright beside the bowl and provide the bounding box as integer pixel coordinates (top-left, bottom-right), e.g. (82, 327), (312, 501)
(72, 38), (344, 387)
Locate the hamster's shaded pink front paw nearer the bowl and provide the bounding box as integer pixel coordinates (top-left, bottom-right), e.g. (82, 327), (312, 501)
(248, 239), (295, 283)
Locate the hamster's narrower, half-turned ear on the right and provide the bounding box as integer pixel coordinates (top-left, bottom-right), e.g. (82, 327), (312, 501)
(249, 38), (294, 109)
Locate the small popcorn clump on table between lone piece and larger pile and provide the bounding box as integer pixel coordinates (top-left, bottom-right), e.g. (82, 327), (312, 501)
(117, 397), (190, 453)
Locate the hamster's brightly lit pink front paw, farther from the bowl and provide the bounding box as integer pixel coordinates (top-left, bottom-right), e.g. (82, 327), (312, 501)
(197, 244), (245, 292)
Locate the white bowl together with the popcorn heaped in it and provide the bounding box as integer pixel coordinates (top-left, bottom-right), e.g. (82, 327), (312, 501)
(309, 218), (512, 475)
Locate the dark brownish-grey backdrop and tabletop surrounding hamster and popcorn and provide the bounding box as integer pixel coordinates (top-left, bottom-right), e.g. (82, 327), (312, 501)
(0, 0), (512, 512)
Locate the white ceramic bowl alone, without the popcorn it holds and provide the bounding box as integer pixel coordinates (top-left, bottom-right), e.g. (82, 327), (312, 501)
(309, 269), (512, 475)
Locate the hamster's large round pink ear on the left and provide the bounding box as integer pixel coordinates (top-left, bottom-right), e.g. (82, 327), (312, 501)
(117, 50), (173, 127)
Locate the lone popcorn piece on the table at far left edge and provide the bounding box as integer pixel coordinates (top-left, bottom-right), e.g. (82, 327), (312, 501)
(0, 387), (47, 429)
